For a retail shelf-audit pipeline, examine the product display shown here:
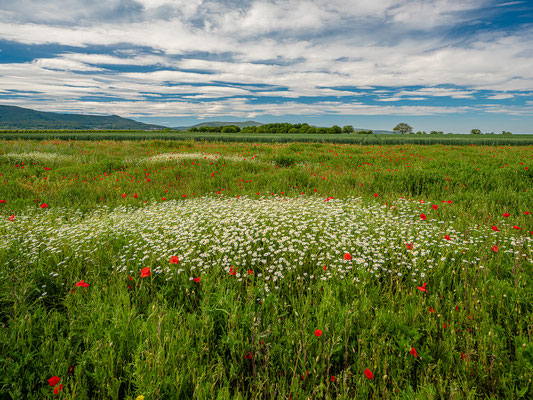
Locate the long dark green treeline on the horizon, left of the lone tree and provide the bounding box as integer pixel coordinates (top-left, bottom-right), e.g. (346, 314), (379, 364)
(187, 123), (374, 135)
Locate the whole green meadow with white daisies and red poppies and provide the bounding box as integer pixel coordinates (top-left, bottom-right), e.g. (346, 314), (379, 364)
(0, 138), (533, 400)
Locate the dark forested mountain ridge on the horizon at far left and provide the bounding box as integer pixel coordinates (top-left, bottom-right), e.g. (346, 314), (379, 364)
(0, 105), (165, 130)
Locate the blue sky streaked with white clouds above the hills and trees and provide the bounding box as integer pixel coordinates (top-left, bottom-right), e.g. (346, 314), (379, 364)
(0, 0), (533, 133)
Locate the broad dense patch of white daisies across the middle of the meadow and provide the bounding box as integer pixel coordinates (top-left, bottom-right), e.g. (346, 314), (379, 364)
(0, 197), (533, 293)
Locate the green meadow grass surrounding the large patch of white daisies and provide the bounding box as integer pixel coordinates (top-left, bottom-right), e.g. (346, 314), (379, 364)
(0, 139), (533, 399)
